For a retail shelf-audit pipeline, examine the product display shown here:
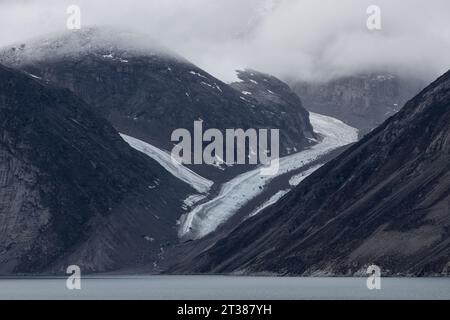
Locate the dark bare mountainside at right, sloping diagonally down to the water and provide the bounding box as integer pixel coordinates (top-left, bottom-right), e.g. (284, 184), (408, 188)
(168, 71), (450, 276)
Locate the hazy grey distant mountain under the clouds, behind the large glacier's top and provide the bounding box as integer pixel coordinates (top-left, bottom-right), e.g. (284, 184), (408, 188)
(292, 73), (426, 134)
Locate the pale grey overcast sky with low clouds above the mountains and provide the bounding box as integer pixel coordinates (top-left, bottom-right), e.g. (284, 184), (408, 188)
(0, 0), (450, 80)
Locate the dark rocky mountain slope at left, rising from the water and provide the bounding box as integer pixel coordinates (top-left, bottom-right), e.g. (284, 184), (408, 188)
(0, 66), (193, 274)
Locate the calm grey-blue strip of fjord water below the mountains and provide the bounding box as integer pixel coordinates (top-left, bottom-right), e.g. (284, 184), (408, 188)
(0, 276), (450, 300)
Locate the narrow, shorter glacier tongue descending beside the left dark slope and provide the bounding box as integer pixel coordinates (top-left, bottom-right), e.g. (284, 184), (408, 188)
(120, 134), (214, 193)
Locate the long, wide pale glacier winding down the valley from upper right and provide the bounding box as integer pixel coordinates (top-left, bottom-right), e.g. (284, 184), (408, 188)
(179, 113), (358, 239)
